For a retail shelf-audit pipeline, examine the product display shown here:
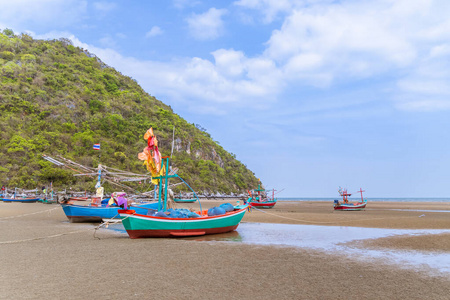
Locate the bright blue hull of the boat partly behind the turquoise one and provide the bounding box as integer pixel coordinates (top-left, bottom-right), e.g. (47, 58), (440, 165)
(61, 202), (158, 223)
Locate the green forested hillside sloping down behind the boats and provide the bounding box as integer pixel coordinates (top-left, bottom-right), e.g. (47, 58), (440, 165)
(0, 29), (257, 194)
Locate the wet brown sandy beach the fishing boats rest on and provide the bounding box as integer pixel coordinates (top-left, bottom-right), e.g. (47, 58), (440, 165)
(0, 199), (450, 299)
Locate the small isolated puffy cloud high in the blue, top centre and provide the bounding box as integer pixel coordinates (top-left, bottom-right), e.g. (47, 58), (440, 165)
(186, 7), (228, 40)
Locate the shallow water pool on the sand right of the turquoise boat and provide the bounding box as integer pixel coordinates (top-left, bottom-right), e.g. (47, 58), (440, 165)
(109, 223), (450, 274)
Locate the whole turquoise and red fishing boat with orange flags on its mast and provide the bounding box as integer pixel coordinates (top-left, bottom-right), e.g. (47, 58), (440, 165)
(119, 128), (248, 239)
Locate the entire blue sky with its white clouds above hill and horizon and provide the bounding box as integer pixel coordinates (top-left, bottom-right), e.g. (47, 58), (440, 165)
(0, 0), (450, 198)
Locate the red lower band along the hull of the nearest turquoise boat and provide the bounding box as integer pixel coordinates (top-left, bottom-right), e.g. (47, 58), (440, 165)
(123, 224), (239, 239)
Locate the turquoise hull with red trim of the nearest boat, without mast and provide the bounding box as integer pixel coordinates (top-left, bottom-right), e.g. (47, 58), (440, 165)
(119, 206), (247, 239)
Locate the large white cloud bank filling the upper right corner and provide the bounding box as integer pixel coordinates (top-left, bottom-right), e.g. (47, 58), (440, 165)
(255, 0), (450, 110)
